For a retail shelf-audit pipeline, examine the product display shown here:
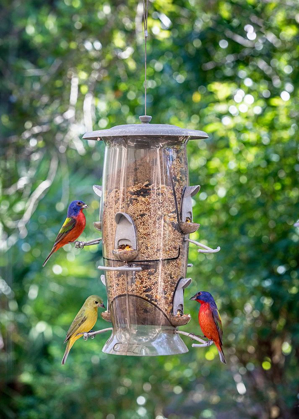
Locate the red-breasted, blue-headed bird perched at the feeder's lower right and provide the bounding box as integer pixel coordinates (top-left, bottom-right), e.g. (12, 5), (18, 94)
(190, 291), (226, 364)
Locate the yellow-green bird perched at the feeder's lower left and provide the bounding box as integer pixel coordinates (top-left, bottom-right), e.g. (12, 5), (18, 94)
(61, 295), (105, 365)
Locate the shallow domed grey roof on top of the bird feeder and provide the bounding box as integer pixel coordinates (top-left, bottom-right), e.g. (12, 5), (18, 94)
(83, 123), (208, 140)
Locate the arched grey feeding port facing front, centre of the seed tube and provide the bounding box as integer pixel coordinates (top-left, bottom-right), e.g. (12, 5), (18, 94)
(112, 212), (138, 262)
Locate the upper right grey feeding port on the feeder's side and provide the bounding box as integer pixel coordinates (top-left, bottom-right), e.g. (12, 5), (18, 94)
(179, 185), (200, 234)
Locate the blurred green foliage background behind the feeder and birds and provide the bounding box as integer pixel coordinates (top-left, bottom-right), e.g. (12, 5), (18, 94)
(0, 0), (299, 419)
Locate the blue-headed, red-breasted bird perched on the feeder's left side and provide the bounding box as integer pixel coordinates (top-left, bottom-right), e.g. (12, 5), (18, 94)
(43, 201), (87, 266)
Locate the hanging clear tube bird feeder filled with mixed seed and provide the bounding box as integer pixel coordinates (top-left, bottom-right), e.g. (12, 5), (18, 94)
(83, 116), (220, 356)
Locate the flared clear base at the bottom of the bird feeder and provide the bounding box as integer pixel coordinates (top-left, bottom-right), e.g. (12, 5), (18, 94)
(103, 325), (188, 356)
